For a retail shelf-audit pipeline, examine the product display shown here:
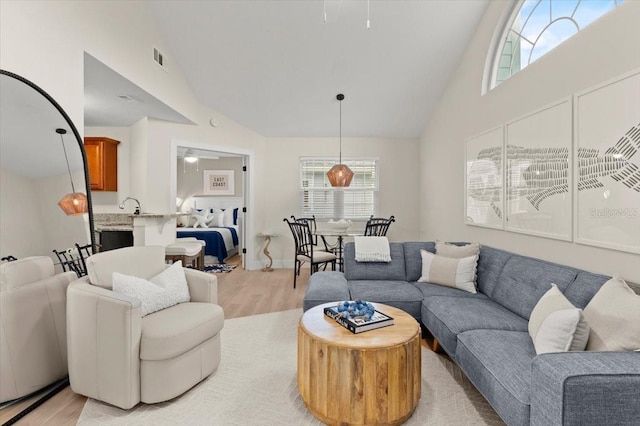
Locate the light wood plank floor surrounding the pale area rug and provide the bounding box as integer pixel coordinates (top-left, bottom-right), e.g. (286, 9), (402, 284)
(0, 256), (309, 426)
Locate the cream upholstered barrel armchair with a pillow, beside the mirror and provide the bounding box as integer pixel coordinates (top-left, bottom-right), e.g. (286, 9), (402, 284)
(67, 246), (224, 409)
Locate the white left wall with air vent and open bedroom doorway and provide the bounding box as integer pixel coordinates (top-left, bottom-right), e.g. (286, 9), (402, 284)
(0, 0), (264, 265)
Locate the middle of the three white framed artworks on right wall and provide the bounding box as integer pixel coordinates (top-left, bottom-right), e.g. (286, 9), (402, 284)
(505, 98), (572, 241)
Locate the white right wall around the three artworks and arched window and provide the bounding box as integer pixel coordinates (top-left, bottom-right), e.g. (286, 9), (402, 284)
(420, 1), (640, 282)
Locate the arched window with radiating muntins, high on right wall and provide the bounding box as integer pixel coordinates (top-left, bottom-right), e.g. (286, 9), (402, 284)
(488, 0), (623, 90)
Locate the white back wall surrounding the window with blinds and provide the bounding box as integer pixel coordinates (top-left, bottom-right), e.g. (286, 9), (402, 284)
(264, 138), (420, 268)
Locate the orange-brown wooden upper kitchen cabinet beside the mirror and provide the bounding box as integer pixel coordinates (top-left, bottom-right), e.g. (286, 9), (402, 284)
(84, 137), (120, 191)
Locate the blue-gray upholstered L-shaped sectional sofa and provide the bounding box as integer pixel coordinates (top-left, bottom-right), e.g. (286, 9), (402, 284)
(303, 242), (640, 425)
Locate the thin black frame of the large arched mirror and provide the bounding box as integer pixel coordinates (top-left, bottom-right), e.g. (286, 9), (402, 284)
(0, 69), (96, 426)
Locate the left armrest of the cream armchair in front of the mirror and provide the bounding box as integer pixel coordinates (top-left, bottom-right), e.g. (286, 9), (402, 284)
(67, 277), (142, 409)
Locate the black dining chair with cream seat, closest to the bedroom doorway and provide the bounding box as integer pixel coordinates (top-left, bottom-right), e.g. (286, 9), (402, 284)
(283, 217), (337, 288)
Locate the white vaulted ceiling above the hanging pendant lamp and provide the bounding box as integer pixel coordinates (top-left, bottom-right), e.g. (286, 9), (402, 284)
(147, 0), (487, 138)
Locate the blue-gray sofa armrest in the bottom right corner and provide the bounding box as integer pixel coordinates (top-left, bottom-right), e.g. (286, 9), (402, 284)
(531, 352), (640, 425)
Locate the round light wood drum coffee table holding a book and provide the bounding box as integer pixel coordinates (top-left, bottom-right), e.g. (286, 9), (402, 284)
(298, 302), (421, 425)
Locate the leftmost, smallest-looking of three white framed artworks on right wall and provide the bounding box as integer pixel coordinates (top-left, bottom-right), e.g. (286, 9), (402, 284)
(464, 126), (504, 229)
